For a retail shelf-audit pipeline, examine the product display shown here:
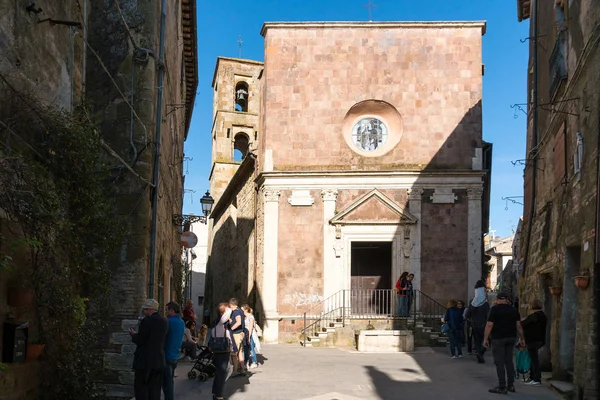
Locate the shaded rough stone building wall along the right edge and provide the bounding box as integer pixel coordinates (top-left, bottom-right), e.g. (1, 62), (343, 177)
(518, 0), (600, 399)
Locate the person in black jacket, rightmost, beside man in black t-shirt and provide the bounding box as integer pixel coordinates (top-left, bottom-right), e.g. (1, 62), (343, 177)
(521, 299), (548, 386)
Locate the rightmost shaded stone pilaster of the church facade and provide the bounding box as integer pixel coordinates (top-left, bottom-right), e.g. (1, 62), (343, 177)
(465, 187), (483, 301)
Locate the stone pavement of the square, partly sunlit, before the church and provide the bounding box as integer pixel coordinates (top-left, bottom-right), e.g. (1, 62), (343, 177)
(175, 345), (560, 400)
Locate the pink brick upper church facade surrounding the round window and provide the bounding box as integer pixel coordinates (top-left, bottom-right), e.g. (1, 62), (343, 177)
(263, 26), (482, 170)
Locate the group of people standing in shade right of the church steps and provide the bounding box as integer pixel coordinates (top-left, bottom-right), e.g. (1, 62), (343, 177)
(443, 280), (547, 394)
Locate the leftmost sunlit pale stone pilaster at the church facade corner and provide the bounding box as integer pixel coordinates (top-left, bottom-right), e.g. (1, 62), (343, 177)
(261, 188), (280, 343)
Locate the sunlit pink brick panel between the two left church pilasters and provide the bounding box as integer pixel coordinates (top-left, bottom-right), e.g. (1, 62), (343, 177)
(277, 190), (323, 315)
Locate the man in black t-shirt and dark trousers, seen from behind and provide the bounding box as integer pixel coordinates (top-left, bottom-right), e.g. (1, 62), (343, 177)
(483, 292), (525, 394)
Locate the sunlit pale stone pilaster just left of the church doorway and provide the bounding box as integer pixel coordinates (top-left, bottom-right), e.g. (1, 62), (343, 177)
(321, 189), (340, 299)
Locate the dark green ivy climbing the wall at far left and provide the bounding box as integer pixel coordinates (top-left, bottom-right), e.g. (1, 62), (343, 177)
(0, 87), (124, 399)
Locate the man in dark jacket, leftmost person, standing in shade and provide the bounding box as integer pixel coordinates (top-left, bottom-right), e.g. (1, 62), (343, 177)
(129, 299), (169, 400)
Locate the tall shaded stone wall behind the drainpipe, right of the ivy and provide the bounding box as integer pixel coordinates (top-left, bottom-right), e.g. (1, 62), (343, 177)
(87, 0), (191, 398)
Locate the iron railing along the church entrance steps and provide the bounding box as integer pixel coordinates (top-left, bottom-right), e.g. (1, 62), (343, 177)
(301, 289), (446, 346)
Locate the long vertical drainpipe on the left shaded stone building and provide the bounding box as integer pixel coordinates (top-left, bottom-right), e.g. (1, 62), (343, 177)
(148, 0), (167, 299)
